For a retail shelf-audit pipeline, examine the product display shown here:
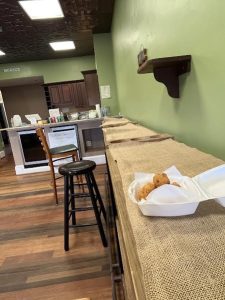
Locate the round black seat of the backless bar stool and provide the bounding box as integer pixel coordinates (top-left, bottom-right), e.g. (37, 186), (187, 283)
(59, 160), (96, 175)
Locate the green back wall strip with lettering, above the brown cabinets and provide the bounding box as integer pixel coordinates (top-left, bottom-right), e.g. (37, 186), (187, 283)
(0, 55), (95, 83)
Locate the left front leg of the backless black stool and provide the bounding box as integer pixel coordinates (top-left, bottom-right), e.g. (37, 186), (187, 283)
(64, 176), (69, 251)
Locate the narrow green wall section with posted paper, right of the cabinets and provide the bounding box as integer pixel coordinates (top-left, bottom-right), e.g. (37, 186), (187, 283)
(94, 33), (118, 114)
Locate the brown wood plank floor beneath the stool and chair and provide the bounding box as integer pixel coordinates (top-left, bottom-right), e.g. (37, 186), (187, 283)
(0, 157), (112, 300)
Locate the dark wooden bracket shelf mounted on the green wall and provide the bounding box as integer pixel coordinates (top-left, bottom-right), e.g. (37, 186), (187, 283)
(137, 55), (191, 98)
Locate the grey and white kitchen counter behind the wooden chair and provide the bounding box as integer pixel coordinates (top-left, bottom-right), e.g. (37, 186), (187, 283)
(5, 118), (105, 175)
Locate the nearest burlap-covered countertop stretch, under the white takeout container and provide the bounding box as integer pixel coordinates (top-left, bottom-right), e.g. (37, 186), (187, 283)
(105, 122), (225, 300)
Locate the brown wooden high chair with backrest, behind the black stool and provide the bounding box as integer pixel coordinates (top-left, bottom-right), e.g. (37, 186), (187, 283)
(36, 128), (79, 204)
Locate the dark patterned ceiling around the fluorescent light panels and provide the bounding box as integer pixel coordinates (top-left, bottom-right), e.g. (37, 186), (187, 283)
(0, 0), (114, 64)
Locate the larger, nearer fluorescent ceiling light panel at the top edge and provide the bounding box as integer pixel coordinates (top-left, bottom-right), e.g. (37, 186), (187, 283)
(19, 0), (64, 20)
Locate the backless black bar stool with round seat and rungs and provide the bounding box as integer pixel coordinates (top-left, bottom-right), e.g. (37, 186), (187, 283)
(59, 160), (107, 251)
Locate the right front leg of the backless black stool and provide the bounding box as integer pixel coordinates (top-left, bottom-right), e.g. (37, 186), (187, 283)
(85, 174), (108, 247)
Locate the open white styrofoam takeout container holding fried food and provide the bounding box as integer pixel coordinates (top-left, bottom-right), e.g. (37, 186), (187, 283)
(128, 165), (225, 217)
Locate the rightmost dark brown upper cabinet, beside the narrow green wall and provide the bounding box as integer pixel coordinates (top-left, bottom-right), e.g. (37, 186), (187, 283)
(82, 70), (100, 106)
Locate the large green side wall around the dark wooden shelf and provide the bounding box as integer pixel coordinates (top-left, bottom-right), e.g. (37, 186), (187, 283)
(112, 0), (225, 159)
